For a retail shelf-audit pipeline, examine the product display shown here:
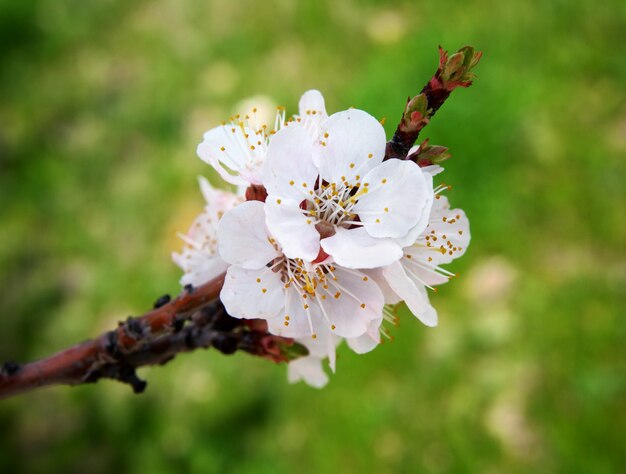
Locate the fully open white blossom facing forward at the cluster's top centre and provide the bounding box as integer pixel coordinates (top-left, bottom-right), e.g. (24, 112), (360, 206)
(263, 97), (433, 268)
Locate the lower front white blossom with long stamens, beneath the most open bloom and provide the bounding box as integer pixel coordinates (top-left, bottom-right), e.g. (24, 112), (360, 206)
(217, 201), (384, 339)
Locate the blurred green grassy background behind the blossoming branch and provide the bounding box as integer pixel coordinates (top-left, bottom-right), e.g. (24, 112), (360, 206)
(0, 0), (626, 474)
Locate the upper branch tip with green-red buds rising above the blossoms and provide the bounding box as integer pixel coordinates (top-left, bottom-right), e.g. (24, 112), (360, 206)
(385, 46), (482, 164)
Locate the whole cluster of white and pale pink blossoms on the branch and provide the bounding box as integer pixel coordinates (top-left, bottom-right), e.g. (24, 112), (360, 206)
(173, 90), (470, 387)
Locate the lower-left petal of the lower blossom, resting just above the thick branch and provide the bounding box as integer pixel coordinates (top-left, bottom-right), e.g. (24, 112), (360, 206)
(220, 265), (285, 319)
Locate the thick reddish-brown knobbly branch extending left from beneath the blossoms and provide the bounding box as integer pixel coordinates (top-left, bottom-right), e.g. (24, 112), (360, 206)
(0, 275), (304, 398)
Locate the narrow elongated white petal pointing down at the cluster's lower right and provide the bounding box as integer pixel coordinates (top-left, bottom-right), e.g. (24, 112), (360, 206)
(383, 262), (437, 327)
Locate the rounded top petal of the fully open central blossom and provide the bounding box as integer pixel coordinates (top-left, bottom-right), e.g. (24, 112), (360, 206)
(315, 109), (387, 183)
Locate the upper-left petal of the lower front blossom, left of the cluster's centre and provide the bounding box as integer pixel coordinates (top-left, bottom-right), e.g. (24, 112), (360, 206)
(217, 201), (281, 269)
